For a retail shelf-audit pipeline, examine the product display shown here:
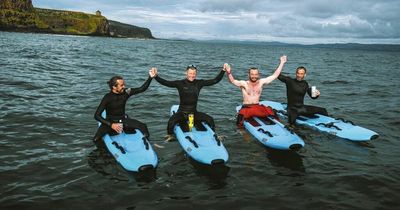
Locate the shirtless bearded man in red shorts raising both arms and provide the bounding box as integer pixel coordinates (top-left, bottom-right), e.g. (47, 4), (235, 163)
(224, 55), (287, 127)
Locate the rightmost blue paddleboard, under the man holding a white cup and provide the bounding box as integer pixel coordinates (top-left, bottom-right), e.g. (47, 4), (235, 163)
(261, 101), (379, 141)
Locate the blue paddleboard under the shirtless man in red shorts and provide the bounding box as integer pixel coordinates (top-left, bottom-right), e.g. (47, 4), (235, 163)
(236, 106), (304, 150)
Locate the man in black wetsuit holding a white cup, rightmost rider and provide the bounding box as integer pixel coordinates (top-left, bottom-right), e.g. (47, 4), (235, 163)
(278, 66), (328, 125)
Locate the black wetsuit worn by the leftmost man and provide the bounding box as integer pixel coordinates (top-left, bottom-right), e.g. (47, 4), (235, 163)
(94, 77), (152, 141)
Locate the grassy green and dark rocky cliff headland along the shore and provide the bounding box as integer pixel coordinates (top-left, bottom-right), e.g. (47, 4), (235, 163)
(0, 0), (154, 39)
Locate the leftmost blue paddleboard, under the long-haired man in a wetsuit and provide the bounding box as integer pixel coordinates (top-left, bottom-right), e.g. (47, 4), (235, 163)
(99, 111), (158, 172)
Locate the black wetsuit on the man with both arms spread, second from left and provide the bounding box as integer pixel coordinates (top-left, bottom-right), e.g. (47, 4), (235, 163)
(155, 71), (224, 135)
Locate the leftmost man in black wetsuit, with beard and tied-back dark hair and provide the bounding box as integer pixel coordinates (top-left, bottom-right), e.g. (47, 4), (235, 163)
(93, 70), (156, 143)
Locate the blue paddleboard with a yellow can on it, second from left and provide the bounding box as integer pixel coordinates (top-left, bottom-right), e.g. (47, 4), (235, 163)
(170, 105), (229, 165)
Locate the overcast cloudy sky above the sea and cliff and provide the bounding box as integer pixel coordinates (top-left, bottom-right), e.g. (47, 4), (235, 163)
(32, 0), (400, 44)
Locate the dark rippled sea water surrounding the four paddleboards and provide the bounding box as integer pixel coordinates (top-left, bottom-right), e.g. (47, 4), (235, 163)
(0, 32), (400, 209)
